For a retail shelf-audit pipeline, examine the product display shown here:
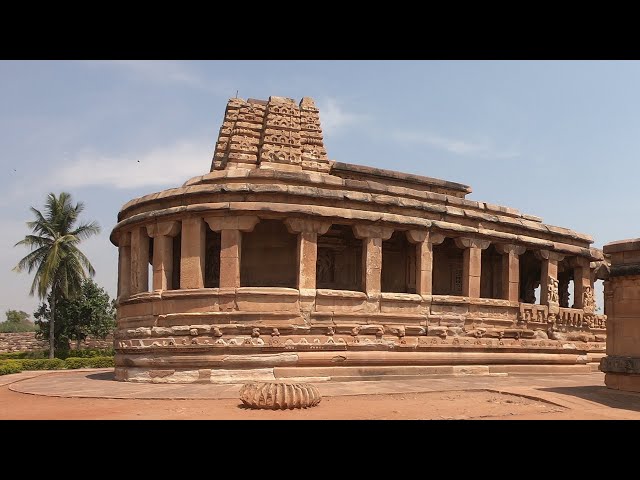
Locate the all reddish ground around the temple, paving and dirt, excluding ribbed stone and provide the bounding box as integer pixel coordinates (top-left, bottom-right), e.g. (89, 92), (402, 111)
(0, 369), (640, 419)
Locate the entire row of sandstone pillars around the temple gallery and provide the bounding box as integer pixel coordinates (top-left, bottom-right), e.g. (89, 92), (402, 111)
(118, 216), (591, 308)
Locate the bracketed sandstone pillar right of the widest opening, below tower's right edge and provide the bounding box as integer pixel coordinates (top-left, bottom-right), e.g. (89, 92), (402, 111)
(284, 218), (331, 290)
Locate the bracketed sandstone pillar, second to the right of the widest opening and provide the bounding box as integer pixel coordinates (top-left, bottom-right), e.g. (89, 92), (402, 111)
(353, 225), (393, 297)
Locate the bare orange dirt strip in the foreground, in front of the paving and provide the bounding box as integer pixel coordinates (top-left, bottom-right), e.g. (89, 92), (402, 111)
(0, 386), (580, 420)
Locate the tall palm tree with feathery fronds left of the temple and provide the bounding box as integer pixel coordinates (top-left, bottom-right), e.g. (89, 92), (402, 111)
(13, 192), (100, 358)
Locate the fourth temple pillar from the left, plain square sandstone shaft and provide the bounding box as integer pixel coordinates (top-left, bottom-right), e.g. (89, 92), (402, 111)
(180, 217), (207, 289)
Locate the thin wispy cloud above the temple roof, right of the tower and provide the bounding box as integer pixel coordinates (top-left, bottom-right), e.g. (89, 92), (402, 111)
(393, 131), (520, 159)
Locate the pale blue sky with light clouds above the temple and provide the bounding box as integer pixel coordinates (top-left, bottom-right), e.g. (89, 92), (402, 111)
(0, 60), (640, 317)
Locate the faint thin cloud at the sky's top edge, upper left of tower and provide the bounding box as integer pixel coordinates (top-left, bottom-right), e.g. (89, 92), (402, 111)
(86, 60), (229, 95)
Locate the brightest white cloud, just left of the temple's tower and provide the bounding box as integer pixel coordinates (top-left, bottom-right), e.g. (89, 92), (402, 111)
(52, 140), (214, 188)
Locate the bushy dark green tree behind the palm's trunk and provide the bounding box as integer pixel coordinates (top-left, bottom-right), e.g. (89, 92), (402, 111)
(34, 278), (116, 349)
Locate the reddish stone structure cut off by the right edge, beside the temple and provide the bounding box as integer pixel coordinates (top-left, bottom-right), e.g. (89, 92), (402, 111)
(600, 238), (640, 392)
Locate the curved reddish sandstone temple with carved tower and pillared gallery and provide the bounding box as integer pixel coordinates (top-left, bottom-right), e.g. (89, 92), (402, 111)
(111, 97), (606, 382)
